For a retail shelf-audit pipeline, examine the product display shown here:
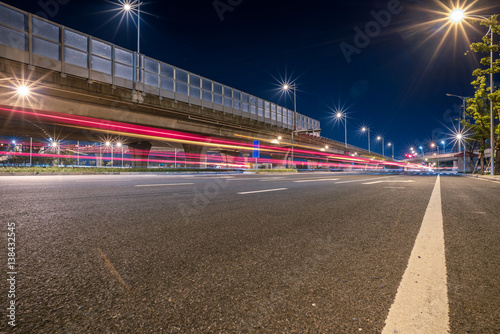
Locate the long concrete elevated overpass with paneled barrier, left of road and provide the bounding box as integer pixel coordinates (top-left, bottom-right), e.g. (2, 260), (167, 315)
(0, 2), (383, 168)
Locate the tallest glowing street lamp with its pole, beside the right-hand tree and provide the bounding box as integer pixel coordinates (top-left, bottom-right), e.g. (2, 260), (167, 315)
(450, 9), (495, 175)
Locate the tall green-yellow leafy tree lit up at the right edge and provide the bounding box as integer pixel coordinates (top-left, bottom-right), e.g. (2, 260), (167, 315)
(464, 15), (500, 174)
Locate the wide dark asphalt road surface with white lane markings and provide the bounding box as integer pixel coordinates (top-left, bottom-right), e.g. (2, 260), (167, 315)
(0, 173), (500, 334)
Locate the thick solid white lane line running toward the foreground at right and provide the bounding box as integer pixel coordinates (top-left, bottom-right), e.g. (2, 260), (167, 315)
(382, 176), (450, 334)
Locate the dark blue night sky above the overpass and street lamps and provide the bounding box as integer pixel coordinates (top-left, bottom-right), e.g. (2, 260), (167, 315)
(4, 0), (500, 157)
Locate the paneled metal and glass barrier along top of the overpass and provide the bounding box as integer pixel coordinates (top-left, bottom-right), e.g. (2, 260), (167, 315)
(0, 2), (321, 131)
